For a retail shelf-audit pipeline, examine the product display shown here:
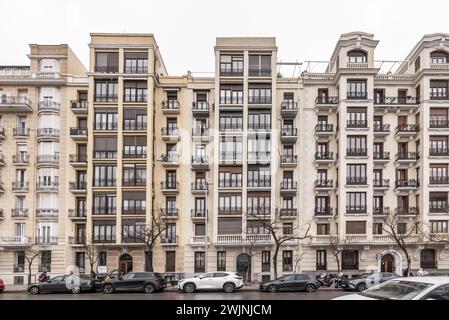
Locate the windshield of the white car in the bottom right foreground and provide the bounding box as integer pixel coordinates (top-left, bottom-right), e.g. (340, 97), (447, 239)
(359, 280), (432, 300)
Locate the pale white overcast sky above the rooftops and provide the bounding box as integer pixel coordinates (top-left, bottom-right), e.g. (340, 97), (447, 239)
(0, 0), (449, 75)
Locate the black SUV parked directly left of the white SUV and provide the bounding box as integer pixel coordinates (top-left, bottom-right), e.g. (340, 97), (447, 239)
(103, 272), (167, 293)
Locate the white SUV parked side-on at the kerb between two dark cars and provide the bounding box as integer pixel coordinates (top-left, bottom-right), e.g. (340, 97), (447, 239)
(178, 272), (243, 293)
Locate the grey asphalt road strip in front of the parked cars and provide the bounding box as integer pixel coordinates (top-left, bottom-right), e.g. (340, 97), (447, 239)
(0, 289), (350, 301)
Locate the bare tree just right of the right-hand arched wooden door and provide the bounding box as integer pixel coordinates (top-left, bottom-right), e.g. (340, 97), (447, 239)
(382, 212), (422, 277)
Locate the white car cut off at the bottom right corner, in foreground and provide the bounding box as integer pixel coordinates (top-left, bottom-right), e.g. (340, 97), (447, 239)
(333, 277), (449, 300)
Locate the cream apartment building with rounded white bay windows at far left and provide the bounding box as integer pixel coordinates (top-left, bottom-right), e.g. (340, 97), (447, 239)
(0, 44), (88, 284)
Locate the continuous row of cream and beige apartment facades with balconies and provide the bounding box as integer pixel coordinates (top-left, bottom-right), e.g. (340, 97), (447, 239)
(0, 32), (449, 282)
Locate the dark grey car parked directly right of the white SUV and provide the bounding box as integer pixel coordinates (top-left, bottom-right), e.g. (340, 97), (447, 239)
(259, 273), (318, 292)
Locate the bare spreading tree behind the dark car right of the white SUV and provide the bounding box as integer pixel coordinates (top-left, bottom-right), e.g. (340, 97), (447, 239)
(247, 214), (311, 278)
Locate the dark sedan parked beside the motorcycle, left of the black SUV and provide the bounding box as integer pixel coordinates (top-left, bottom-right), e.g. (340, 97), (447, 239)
(28, 274), (95, 294)
